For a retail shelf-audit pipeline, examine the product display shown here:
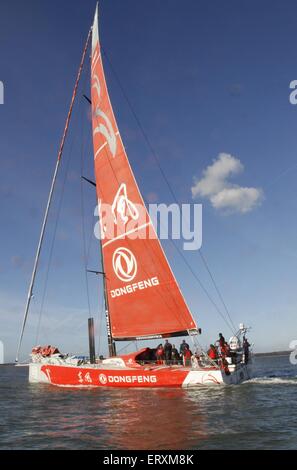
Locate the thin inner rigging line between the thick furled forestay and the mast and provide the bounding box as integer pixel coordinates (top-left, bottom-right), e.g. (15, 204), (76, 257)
(35, 70), (87, 344)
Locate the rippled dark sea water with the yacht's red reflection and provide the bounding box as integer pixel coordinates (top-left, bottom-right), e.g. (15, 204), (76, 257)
(0, 356), (297, 450)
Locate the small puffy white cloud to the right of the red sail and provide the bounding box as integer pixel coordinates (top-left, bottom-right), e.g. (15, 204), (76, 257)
(191, 153), (263, 214)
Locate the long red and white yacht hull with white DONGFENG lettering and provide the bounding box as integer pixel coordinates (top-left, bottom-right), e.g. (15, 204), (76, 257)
(29, 363), (251, 388)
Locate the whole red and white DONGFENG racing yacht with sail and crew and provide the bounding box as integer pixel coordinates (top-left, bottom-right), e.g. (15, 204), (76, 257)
(17, 5), (250, 387)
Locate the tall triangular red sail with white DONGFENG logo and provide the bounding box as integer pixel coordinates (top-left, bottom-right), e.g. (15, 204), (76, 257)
(91, 4), (197, 340)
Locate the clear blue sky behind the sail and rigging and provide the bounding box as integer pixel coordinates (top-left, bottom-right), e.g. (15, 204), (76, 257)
(0, 0), (297, 359)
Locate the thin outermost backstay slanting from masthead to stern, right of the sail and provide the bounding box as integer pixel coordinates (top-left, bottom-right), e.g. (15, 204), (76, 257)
(101, 46), (235, 332)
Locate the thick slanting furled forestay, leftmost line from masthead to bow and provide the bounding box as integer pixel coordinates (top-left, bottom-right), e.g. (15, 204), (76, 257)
(15, 29), (91, 362)
